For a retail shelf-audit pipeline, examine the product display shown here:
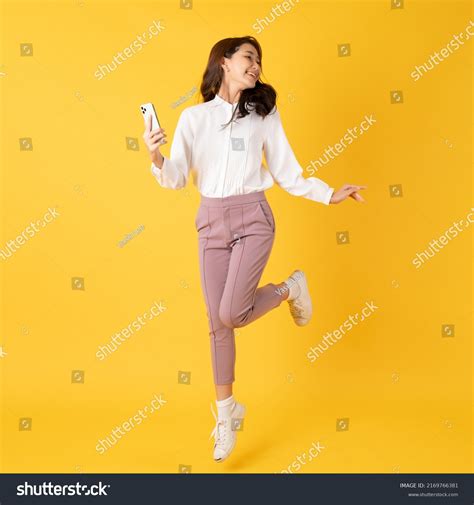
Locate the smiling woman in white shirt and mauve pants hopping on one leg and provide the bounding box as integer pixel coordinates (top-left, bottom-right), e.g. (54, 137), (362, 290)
(143, 36), (366, 461)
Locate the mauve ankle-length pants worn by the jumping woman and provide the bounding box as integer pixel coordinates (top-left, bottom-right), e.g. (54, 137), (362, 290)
(195, 191), (283, 384)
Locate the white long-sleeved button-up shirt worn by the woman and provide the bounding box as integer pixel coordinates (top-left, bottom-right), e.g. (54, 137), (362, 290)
(151, 95), (334, 205)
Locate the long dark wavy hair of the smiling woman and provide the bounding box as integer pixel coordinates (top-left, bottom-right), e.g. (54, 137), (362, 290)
(200, 35), (277, 127)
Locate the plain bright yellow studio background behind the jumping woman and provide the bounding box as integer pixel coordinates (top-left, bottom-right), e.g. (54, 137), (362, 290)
(0, 0), (473, 473)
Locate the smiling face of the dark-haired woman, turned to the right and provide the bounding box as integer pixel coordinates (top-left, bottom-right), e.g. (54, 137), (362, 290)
(223, 42), (260, 89)
